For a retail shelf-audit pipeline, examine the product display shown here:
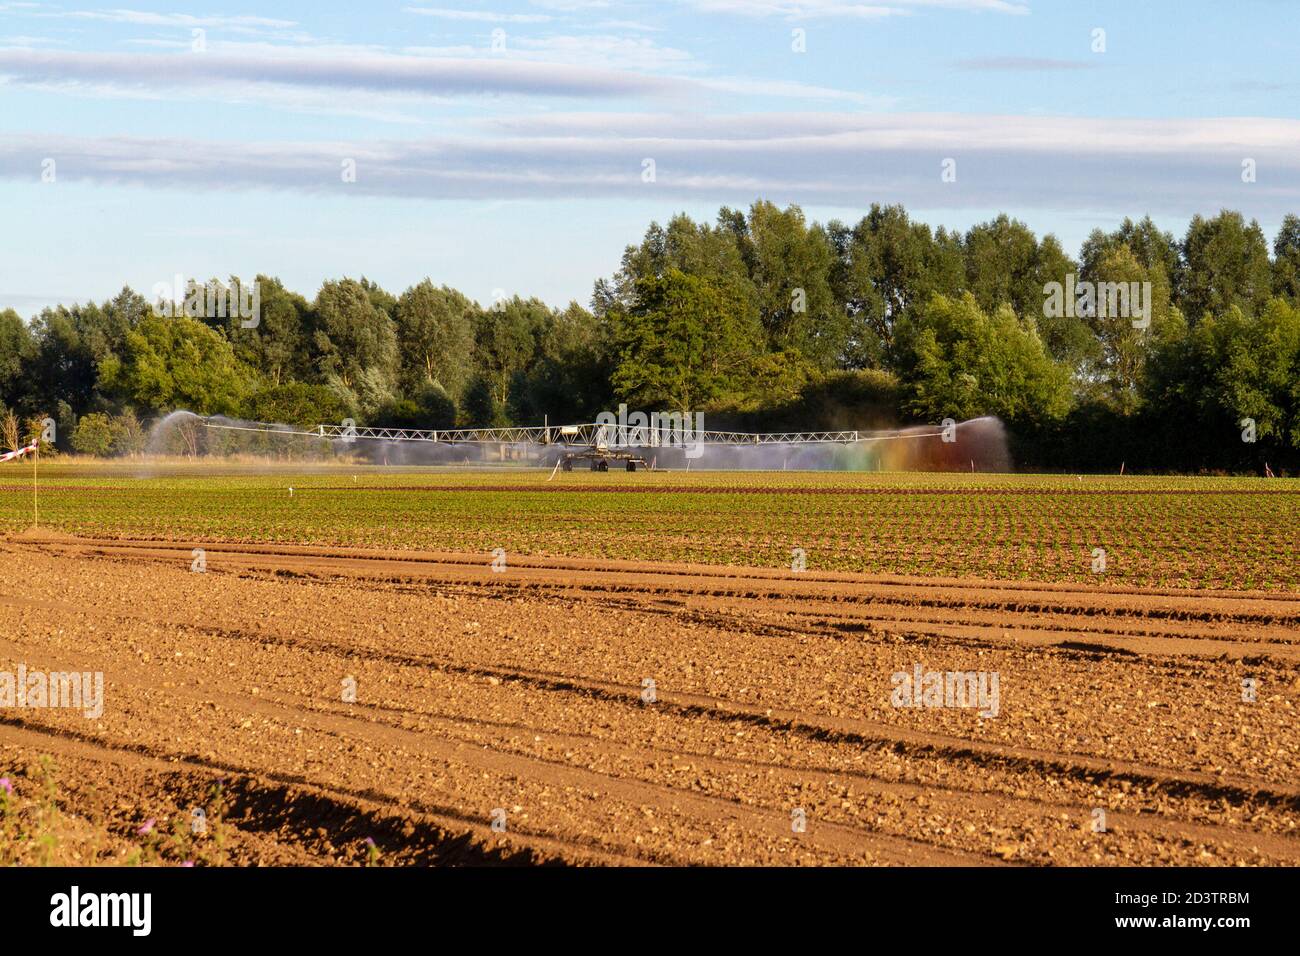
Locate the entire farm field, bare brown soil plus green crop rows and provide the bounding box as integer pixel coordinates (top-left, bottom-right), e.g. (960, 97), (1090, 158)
(0, 463), (1300, 865)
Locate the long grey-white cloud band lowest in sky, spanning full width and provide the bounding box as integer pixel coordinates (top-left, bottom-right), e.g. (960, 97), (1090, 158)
(0, 113), (1300, 215)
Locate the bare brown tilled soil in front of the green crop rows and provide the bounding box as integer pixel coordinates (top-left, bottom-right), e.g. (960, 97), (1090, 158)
(0, 535), (1300, 865)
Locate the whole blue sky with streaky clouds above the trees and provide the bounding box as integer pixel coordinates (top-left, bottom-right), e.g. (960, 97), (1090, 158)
(0, 0), (1300, 316)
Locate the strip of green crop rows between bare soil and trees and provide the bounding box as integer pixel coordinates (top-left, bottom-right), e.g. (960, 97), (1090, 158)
(0, 464), (1300, 591)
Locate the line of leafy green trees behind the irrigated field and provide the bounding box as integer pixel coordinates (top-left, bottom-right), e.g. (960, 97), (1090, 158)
(0, 202), (1300, 471)
